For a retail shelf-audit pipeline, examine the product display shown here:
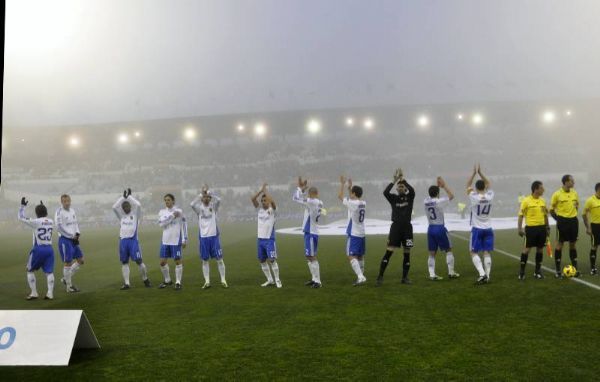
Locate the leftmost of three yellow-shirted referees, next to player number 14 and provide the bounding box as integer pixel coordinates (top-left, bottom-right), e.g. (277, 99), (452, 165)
(518, 180), (550, 280)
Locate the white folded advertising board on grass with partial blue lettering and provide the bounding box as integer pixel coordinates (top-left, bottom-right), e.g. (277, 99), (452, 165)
(0, 310), (100, 366)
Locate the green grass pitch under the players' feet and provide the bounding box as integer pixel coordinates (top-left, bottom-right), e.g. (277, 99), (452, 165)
(0, 223), (600, 381)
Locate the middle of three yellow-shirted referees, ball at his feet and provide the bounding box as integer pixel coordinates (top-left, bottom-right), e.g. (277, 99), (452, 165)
(550, 175), (581, 279)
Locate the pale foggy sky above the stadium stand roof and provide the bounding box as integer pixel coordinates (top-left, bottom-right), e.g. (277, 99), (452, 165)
(3, 0), (600, 126)
